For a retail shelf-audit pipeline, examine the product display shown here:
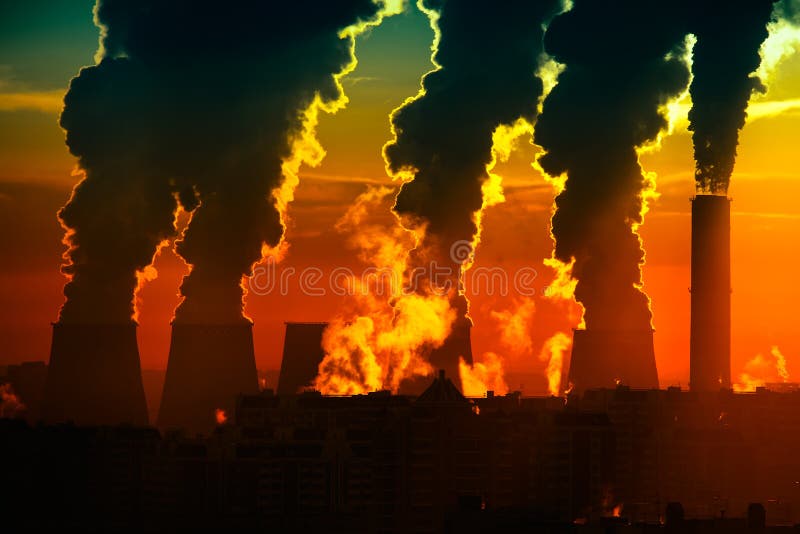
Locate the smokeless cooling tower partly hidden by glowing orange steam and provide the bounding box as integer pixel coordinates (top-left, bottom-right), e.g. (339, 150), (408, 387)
(278, 323), (328, 395)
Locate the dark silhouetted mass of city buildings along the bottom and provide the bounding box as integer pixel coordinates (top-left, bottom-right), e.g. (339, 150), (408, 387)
(7, 382), (800, 534)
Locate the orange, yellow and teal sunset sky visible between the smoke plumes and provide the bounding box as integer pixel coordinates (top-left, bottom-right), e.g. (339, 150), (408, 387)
(0, 1), (800, 394)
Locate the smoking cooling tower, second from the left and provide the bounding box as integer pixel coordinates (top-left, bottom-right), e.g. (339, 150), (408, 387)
(158, 322), (258, 434)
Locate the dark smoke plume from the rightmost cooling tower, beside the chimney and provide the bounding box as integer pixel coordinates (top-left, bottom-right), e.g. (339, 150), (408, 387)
(535, 0), (689, 330)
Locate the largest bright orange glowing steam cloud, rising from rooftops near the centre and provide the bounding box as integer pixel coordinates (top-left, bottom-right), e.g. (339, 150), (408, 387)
(314, 187), (455, 395)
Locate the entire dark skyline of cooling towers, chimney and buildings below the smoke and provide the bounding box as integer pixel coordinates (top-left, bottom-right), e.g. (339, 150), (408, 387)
(2, 189), (800, 533)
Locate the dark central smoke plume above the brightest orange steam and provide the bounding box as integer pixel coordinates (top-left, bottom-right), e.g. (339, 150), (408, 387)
(385, 0), (561, 302)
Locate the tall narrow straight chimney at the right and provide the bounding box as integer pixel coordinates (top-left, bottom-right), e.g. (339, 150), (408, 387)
(689, 195), (731, 391)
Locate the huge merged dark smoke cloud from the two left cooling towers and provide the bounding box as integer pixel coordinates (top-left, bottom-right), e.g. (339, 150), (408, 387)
(60, 0), (381, 322)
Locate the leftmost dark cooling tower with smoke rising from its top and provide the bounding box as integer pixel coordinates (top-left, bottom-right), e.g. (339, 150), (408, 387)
(42, 322), (147, 426)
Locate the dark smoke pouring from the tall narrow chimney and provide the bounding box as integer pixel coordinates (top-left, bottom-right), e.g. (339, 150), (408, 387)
(689, 0), (780, 194)
